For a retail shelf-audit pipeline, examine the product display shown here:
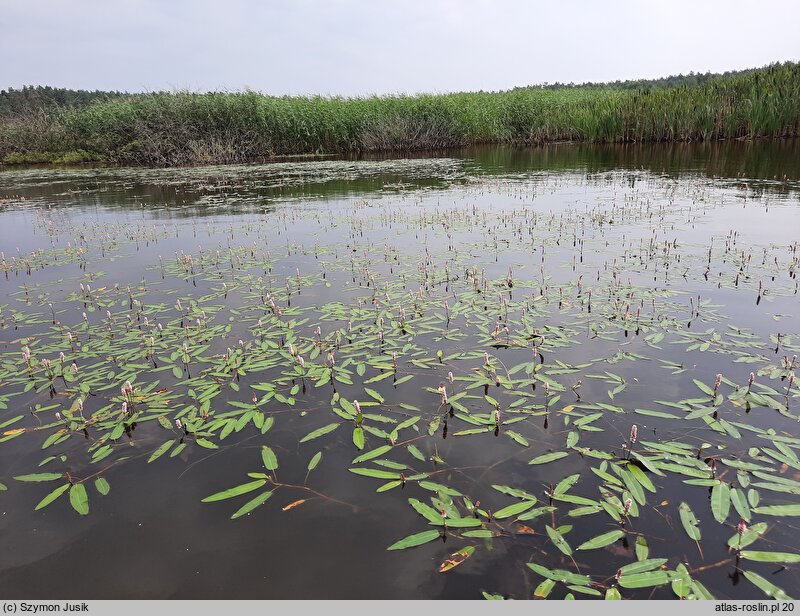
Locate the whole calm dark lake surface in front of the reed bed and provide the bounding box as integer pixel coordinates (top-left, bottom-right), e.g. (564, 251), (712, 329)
(0, 141), (800, 599)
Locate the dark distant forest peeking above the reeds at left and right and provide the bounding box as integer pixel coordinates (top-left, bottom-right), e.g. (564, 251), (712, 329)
(0, 68), (780, 116)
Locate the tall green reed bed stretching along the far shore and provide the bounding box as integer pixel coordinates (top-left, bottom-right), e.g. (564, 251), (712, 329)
(0, 63), (800, 165)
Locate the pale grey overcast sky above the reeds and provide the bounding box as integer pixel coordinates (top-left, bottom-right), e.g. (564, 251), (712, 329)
(0, 0), (800, 95)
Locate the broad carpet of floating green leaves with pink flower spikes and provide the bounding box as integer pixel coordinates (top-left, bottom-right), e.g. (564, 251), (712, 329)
(0, 152), (800, 599)
